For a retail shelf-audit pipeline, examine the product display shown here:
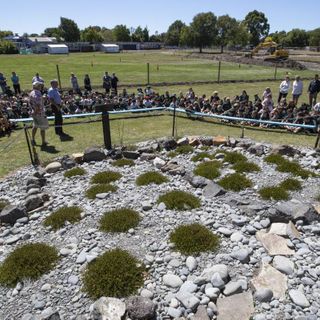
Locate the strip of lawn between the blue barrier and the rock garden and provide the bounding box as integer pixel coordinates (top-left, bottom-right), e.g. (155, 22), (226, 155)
(0, 113), (315, 177)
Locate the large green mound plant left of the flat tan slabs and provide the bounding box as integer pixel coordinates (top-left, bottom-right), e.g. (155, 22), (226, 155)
(170, 223), (219, 255)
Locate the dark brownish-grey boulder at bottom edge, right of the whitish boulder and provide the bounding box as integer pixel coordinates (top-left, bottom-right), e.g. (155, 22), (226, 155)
(126, 296), (156, 320)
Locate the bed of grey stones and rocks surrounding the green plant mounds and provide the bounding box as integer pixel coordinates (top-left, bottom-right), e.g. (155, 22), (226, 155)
(0, 137), (320, 320)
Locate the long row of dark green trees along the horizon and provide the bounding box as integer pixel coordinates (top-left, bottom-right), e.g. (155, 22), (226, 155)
(0, 10), (320, 53)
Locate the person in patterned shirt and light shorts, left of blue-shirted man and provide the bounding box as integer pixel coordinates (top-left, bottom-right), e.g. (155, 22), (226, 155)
(29, 82), (49, 147)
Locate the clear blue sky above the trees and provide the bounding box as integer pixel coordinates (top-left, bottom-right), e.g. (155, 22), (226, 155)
(0, 0), (320, 35)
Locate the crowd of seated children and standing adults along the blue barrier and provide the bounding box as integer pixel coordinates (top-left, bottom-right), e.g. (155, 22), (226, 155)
(0, 72), (320, 138)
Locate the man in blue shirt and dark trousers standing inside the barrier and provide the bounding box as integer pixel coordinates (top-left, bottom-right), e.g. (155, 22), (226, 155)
(48, 79), (65, 137)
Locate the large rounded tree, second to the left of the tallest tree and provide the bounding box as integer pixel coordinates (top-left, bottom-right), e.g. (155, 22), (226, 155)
(190, 12), (217, 53)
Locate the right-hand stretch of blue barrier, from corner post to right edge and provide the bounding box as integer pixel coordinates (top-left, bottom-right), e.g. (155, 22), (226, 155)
(167, 107), (317, 129)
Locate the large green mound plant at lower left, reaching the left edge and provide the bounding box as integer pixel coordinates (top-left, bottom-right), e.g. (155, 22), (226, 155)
(0, 243), (58, 287)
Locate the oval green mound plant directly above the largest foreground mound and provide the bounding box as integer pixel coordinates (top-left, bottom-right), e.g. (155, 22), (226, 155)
(100, 208), (140, 232)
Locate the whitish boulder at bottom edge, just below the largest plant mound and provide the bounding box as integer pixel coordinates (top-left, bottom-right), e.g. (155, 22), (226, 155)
(89, 297), (126, 320)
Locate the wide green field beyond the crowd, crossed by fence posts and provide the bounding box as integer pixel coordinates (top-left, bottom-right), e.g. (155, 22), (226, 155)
(1, 51), (314, 89)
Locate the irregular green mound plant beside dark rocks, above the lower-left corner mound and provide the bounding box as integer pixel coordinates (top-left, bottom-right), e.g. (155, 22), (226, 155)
(43, 207), (82, 230)
